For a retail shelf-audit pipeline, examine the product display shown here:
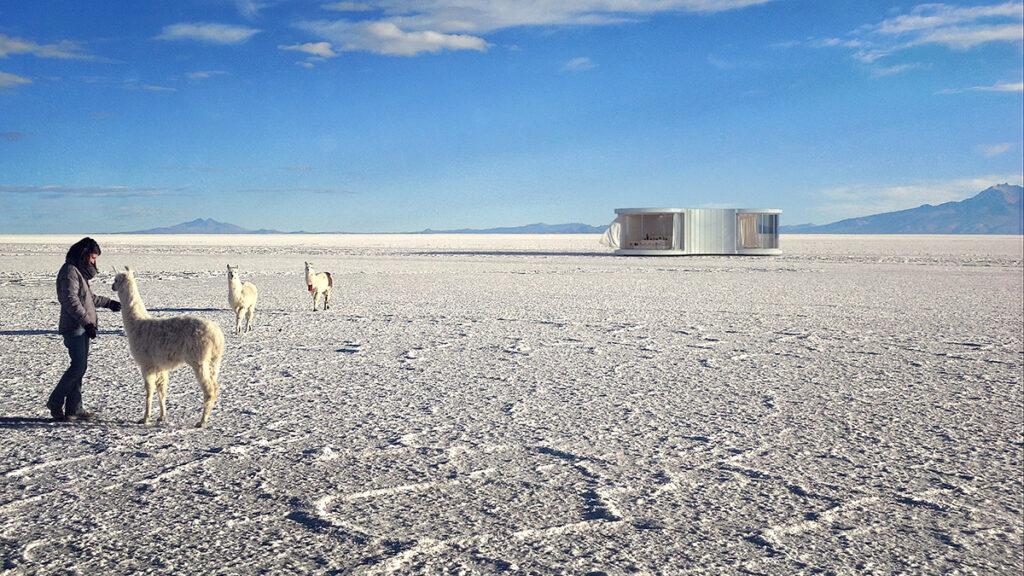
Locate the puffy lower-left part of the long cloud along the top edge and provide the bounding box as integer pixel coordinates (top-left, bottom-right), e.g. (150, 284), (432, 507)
(303, 20), (488, 56)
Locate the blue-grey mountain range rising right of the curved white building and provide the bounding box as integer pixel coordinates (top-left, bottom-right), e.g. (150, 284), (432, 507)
(778, 184), (1024, 234)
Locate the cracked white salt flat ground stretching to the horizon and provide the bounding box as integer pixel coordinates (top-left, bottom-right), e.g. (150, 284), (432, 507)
(0, 236), (1024, 574)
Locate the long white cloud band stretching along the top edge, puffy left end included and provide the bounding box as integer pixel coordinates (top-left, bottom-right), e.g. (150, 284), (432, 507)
(298, 0), (769, 56)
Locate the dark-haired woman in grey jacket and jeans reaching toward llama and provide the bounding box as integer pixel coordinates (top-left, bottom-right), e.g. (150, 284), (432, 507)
(46, 238), (121, 420)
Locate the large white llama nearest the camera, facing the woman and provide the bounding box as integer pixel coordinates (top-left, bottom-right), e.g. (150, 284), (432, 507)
(111, 266), (224, 427)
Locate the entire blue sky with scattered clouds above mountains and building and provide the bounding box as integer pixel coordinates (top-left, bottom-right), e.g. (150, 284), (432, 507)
(0, 0), (1024, 233)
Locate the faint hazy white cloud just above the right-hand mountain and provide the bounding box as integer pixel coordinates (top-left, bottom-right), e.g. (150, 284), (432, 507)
(813, 174), (1024, 221)
